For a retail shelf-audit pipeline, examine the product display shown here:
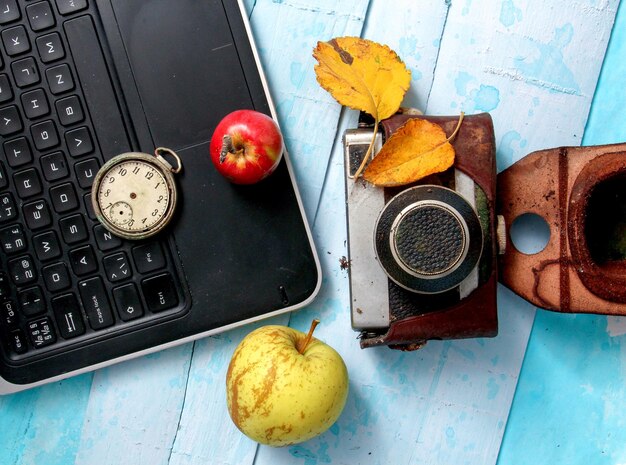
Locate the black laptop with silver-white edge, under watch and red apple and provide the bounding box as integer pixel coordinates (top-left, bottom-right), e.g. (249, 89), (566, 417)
(0, 0), (321, 394)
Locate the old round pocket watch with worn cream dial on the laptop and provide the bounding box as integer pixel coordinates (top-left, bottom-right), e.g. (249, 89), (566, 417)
(91, 147), (182, 239)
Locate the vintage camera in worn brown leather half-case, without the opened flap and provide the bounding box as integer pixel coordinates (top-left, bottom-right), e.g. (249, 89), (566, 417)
(344, 114), (498, 350)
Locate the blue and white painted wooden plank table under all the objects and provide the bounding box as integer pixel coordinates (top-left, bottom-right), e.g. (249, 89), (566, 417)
(0, 0), (626, 465)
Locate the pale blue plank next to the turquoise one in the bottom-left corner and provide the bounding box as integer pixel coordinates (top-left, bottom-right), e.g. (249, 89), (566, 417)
(73, 344), (193, 465)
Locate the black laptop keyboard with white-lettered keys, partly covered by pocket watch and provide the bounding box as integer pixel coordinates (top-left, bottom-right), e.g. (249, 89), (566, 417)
(0, 0), (183, 361)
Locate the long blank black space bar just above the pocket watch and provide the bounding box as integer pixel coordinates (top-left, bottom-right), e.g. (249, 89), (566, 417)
(63, 16), (130, 154)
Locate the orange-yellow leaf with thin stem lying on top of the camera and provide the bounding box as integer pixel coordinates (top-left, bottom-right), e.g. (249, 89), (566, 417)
(363, 115), (454, 187)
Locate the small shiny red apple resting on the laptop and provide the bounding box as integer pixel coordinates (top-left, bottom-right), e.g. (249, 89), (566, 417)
(209, 110), (283, 184)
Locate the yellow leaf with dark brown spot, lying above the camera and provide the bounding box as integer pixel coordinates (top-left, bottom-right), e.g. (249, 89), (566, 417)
(313, 37), (411, 121)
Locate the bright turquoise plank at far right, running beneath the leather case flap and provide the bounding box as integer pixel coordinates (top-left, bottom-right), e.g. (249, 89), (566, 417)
(498, 2), (626, 465)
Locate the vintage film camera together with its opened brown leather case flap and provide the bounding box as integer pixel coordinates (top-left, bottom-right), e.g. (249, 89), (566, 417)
(344, 110), (626, 350)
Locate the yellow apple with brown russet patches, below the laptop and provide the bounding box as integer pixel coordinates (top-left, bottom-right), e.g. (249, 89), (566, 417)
(226, 320), (348, 447)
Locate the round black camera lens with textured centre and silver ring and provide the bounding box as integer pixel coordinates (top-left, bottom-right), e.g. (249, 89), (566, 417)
(374, 185), (483, 294)
